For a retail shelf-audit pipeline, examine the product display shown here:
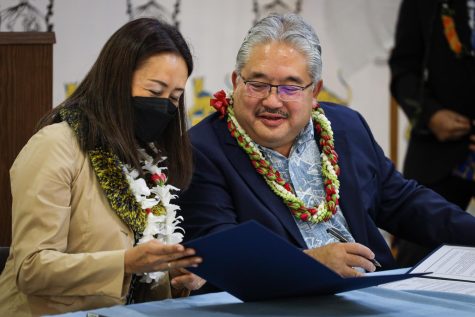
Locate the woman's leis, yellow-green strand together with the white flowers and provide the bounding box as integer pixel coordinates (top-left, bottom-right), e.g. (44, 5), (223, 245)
(60, 108), (184, 283)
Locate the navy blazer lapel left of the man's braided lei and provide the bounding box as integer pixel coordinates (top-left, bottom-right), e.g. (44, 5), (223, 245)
(213, 120), (307, 248)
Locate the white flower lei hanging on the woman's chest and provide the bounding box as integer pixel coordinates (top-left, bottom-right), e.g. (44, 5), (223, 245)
(123, 149), (185, 283)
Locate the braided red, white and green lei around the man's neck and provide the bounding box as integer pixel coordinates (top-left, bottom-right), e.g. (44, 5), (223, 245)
(210, 90), (340, 223)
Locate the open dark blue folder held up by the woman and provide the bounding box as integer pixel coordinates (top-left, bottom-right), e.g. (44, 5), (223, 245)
(184, 221), (422, 302)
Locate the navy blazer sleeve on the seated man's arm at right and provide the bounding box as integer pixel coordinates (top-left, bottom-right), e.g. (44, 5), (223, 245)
(353, 114), (475, 247)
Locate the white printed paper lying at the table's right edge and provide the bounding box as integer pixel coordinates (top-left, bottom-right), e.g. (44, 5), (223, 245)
(380, 245), (475, 296)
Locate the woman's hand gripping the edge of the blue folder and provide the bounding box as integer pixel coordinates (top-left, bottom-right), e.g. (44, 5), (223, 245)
(124, 240), (202, 274)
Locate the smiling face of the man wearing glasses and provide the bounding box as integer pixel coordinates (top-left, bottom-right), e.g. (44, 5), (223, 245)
(232, 42), (321, 156)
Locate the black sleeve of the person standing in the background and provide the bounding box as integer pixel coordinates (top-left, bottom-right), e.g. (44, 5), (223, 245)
(389, 0), (443, 134)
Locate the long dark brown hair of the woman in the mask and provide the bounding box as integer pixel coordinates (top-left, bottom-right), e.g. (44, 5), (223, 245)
(38, 18), (193, 188)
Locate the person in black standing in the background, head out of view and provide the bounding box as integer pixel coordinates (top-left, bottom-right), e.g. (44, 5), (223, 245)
(389, 0), (475, 266)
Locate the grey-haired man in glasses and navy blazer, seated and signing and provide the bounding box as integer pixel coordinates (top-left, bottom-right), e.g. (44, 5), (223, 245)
(179, 14), (475, 276)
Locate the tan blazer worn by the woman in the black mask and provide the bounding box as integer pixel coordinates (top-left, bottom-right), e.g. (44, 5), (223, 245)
(0, 122), (170, 316)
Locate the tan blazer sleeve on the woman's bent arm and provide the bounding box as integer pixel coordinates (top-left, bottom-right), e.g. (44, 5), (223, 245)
(10, 123), (128, 298)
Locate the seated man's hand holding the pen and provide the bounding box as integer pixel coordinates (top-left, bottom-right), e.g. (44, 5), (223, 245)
(304, 243), (376, 277)
